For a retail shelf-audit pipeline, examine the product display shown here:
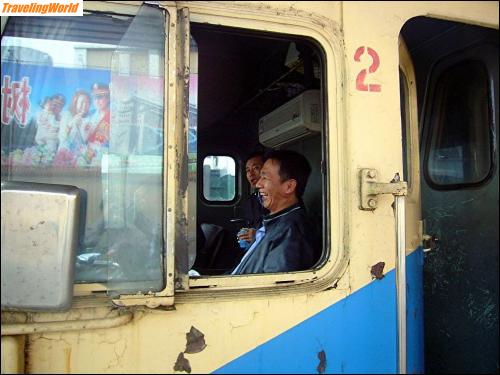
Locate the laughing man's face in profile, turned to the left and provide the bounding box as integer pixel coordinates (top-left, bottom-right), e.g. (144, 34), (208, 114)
(256, 159), (290, 213)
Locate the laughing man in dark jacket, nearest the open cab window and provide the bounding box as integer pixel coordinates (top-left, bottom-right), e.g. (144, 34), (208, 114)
(231, 150), (316, 275)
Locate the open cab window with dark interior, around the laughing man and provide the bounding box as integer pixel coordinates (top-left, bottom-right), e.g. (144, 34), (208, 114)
(188, 22), (327, 280)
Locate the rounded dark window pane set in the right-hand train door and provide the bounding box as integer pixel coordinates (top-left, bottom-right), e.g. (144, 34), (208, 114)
(427, 60), (492, 186)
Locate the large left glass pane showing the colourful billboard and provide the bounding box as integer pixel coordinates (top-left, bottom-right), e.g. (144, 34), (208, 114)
(1, 6), (165, 292)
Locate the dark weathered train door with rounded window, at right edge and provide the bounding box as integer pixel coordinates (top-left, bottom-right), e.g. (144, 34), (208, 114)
(401, 17), (498, 373)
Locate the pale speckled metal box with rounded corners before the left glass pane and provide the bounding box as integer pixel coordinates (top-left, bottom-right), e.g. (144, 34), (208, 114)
(1, 182), (80, 310)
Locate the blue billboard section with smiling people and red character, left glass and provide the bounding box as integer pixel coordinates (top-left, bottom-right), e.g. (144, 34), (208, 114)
(1, 63), (110, 166)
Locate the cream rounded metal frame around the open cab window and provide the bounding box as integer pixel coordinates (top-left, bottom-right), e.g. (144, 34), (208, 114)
(180, 3), (348, 300)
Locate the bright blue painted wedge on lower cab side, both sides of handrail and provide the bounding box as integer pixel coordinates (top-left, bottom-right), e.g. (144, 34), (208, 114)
(215, 251), (423, 374)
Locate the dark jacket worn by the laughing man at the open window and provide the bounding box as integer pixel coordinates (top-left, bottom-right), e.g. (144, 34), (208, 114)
(231, 204), (317, 275)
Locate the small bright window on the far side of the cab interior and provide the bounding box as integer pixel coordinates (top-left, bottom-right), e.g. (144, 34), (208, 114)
(203, 156), (236, 202)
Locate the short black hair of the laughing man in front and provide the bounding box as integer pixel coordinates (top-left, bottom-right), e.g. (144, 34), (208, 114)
(265, 150), (311, 198)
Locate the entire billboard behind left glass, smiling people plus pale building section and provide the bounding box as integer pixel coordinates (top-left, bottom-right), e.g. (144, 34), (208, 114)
(1, 62), (163, 167)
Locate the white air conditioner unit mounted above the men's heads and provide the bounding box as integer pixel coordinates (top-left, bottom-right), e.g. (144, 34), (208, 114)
(259, 90), (321, 147)
